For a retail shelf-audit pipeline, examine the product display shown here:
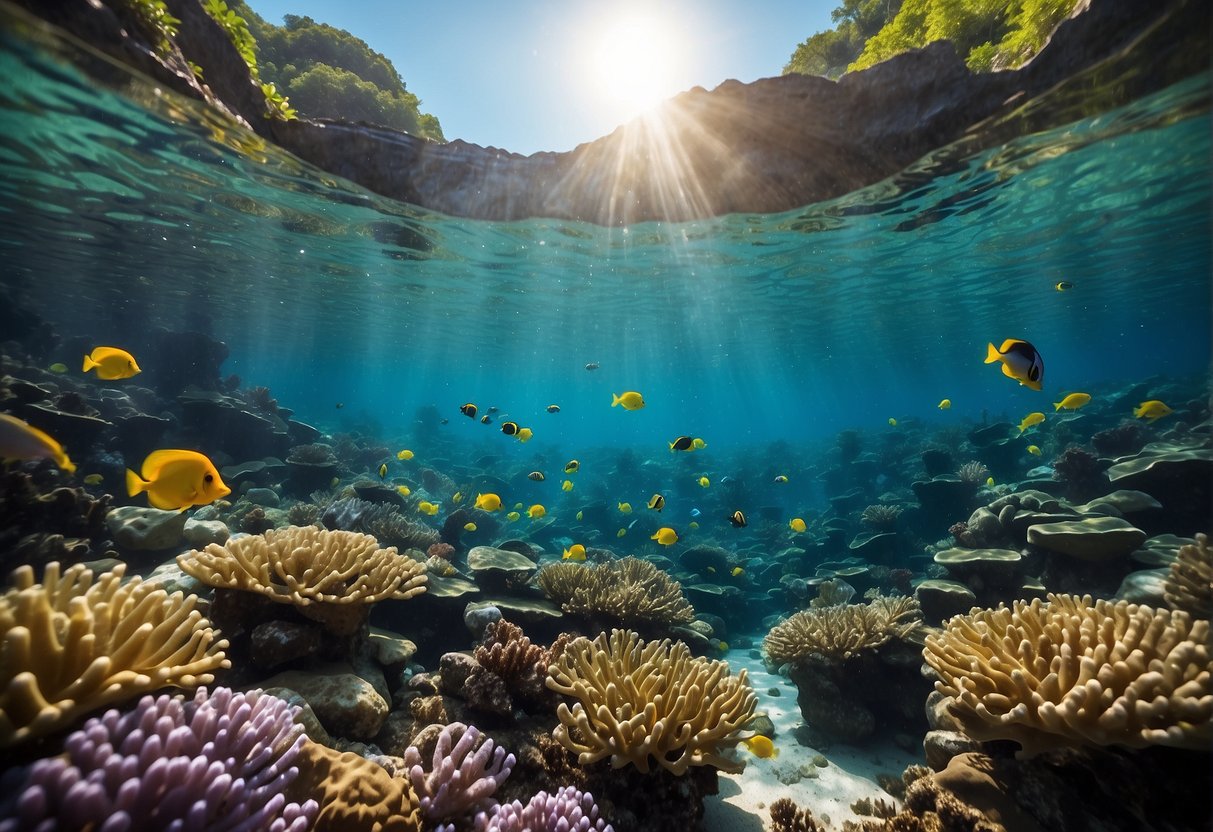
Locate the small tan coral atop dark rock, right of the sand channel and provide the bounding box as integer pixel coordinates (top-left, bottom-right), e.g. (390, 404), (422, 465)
(763, 595), (922, 665)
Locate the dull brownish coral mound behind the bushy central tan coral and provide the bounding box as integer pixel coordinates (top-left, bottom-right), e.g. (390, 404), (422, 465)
(536, 558), (695, 625)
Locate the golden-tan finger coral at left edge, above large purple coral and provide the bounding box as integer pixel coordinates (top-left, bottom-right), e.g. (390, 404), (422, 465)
(0, 563), (230, 747)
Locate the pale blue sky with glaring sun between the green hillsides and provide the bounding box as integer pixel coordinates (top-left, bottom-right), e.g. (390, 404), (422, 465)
(242, 0), (837, 153)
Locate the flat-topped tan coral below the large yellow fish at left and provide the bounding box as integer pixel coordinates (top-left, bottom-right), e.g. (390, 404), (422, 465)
(177, 526), (427, 608)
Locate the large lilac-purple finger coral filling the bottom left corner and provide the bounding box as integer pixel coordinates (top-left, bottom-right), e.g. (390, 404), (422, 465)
(0, 688), (318, 832)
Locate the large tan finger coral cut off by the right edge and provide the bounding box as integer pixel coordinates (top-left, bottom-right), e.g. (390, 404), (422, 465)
(923, 594), (1213, 756)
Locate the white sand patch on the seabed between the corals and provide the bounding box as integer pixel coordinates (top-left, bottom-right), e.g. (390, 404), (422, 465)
(702, 649), (924, 832)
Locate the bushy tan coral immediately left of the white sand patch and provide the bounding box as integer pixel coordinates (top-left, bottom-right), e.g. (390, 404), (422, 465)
(547, 629), (758, 775)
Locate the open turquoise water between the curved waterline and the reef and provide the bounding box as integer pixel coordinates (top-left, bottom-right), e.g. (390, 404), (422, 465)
(0, 19), (1211, 514)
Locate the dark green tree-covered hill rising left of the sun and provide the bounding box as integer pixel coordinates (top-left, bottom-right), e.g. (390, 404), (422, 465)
(230, 0), (446, 142)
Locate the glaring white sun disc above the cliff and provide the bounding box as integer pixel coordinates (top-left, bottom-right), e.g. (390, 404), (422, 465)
(592, 13), (683, 118)
